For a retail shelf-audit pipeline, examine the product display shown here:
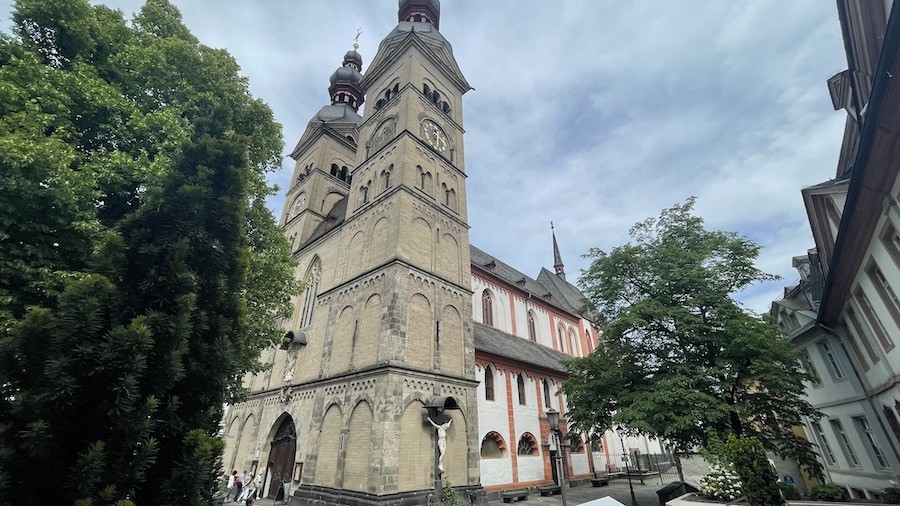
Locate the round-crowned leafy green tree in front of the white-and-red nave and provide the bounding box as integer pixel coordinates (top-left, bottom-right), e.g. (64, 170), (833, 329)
(562, 199), (821, 474)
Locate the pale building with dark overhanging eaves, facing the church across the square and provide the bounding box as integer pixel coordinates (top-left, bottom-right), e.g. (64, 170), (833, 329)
(772, 0), (900, 499)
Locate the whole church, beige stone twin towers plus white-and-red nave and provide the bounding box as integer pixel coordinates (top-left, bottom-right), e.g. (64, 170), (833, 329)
(223, 0), (658, 504)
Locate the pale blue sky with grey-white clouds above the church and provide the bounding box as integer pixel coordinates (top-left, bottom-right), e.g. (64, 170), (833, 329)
(0, 0), (846, 311)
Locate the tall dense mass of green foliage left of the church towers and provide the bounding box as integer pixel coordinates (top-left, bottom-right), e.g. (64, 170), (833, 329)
(0, 0), (299, 505)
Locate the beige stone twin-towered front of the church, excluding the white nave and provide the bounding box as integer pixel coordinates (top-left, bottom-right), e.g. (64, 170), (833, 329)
(225, 0), (481, 505)
